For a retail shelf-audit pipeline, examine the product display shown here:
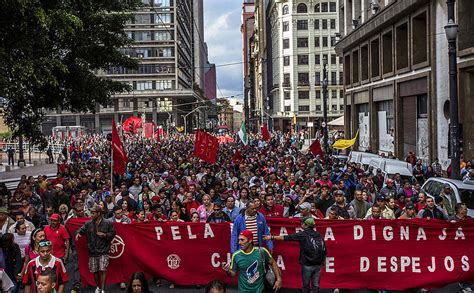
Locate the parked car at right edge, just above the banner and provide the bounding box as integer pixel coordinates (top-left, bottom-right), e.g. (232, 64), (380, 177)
(421, 177), (474, 217)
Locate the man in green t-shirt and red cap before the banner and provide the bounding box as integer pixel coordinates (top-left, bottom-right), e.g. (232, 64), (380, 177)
(222, 230), (282, 293)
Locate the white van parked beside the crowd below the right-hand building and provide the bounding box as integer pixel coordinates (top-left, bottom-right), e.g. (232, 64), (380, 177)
(369, 157), (416, 185)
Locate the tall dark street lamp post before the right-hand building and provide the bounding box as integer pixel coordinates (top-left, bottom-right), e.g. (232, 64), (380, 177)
(444, 0), (461, 179)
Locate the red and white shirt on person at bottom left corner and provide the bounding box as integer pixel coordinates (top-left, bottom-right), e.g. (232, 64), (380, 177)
(23, 255), (69, 293)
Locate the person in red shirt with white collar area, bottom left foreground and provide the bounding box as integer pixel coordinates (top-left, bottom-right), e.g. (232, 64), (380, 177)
(23, 241), (69, 293)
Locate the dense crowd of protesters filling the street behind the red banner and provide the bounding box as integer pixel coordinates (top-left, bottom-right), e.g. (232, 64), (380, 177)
(0, 132), (474, 292)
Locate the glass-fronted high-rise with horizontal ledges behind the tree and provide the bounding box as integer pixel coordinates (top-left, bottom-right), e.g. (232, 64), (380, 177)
(42, 0), (207, 134)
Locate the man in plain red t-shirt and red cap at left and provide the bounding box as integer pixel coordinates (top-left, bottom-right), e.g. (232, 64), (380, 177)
(44, 214), (71, 261)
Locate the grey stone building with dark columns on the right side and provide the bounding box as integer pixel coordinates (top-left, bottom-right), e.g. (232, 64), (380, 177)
(336, 0), (474, 168)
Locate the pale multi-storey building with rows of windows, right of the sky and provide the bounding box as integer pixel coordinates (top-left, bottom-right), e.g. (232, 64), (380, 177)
(263, 0), (344, 131)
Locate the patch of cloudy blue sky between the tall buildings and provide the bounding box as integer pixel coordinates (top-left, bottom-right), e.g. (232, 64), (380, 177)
(204, 0), (243, 99)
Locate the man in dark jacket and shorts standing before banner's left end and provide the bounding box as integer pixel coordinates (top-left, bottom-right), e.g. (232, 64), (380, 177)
(75, 204), (116, 293)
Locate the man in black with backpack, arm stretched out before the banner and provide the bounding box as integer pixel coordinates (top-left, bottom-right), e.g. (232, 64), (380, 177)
(264, 217), (326, 292)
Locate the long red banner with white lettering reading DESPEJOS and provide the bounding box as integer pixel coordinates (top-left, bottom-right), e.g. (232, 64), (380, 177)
(68, 219), (474, 290)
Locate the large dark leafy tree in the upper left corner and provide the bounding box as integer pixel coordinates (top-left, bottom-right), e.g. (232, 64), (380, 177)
(0, 0), (139, 145)
